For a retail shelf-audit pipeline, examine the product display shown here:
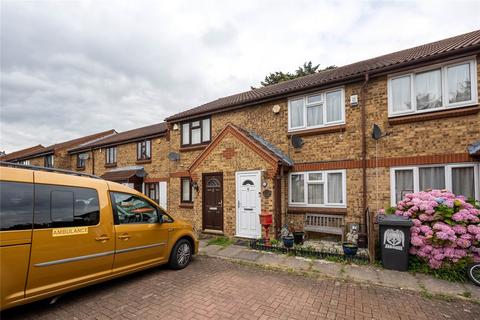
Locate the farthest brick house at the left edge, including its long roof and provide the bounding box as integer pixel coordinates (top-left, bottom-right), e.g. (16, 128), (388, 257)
(0, 129), (115, 170)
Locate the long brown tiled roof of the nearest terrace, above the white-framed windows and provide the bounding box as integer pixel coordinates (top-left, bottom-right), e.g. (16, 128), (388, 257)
(166, 30), (480, 121)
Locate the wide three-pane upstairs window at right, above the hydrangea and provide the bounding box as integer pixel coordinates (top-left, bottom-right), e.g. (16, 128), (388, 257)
(388, 60), (478, 116)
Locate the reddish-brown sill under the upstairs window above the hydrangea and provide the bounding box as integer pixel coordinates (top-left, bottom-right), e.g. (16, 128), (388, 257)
(388, 104), (480, 125)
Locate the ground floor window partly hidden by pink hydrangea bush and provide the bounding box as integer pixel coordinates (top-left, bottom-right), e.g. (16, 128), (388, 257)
(390, 163), (480, 205)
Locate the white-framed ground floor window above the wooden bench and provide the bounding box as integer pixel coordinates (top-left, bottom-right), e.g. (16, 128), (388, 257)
(289, 170), (347, 207)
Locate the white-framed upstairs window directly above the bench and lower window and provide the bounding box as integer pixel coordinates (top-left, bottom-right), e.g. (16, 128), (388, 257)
(288, 89), (345, 131)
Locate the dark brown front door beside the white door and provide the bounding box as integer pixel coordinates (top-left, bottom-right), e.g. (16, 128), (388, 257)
(203, 173), (223, 231)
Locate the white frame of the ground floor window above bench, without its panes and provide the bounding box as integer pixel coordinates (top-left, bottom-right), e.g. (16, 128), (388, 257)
(288, 169), (347, 208)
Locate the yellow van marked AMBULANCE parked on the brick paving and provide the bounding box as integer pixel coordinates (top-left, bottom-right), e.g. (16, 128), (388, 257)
(0, 163), (198, 310)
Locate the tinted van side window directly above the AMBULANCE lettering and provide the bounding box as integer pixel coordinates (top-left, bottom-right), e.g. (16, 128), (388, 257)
(34, 184), (100, 229)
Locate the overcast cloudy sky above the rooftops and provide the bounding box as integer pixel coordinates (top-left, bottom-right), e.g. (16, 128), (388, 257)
(0, 0), (480, 152)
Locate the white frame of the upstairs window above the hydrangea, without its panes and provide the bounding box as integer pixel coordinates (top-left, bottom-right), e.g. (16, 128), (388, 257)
(388, 56), (478, 117)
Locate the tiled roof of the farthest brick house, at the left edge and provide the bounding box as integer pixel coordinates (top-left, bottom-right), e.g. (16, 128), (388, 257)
(0, 129), (115, 161)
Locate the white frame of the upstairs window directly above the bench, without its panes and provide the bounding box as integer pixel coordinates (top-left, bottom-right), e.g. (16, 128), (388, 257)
(288, 87), (345, 132)
